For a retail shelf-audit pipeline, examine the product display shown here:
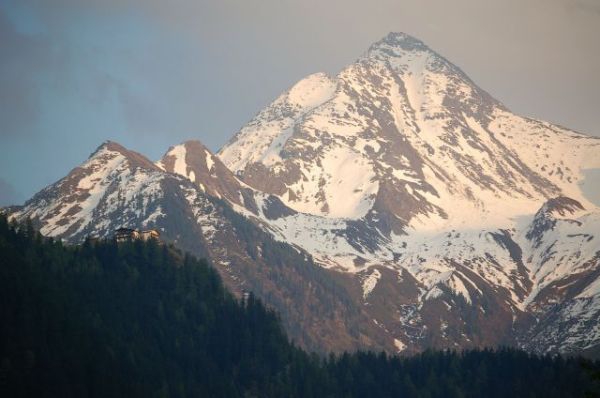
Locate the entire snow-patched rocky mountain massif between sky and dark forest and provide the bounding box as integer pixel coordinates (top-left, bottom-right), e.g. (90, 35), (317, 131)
(11, 33), (600, 353)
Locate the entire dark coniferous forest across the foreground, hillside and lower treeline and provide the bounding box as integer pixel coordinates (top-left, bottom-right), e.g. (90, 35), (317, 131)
(0, 216), (600, 397)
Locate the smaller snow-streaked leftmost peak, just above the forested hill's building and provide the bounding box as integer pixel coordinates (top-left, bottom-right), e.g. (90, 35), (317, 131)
(13, 141), (170, 240)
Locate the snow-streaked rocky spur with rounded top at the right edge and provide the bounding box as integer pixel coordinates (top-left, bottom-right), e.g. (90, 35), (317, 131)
(520, 197), (600, 352)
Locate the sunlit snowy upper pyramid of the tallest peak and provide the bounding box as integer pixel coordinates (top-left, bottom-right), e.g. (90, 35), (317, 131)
(219, 34), (600, 234)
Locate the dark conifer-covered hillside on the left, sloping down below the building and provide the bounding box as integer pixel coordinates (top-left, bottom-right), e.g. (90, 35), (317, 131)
(0, 214), (302, 398)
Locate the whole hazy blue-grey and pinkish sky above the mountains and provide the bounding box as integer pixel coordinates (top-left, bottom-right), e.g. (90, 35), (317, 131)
(0, 0), (600, 205)
